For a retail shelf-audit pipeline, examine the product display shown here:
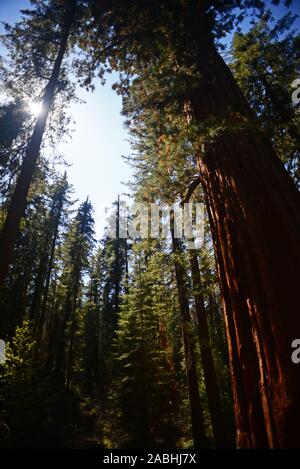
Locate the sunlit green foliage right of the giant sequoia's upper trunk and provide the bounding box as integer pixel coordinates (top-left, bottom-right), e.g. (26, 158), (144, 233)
(230, 12), (300, 186)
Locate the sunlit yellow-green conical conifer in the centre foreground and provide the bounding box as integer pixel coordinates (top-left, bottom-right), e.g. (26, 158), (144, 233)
(109, 243), (184, 448)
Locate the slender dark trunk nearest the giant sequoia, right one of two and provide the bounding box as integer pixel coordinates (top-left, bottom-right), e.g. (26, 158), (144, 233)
(189, 251), (229, 448)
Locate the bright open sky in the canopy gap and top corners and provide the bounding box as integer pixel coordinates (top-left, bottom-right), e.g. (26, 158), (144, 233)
(0, 0), (300, 237)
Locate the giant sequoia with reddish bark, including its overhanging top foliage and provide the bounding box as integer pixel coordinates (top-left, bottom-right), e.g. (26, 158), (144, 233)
(82, 0), (300, 448)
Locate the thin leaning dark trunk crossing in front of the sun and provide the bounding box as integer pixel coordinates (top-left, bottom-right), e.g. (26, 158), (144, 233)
(0, 0), (75, 288)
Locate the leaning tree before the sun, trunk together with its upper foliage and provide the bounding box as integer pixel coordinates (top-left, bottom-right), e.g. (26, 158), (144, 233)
(0, 0), (84, 286)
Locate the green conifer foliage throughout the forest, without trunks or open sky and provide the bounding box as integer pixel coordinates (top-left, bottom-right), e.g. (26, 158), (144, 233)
(0, 0), (299, 448)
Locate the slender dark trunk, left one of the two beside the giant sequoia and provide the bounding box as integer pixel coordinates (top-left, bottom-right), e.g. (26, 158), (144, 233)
(171, 220), (206, 448)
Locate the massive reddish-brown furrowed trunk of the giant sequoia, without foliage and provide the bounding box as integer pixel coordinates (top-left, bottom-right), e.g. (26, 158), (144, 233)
(190, 46), (300, 448)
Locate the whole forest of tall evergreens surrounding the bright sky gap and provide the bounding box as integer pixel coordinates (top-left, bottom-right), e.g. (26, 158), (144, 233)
(0, 0), (300, 449)
